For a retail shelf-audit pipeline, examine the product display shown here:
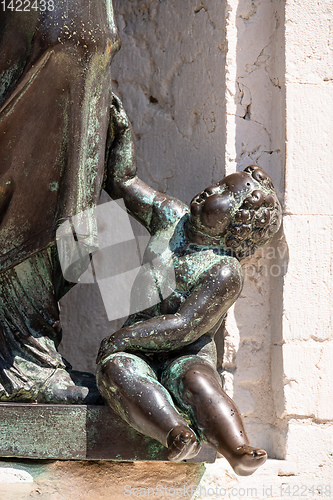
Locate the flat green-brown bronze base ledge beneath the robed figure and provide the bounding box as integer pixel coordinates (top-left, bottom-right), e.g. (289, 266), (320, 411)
(0, 403), (216, 462)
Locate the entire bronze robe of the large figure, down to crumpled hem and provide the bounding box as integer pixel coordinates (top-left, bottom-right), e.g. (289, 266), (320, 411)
(0, 0), (120, 401)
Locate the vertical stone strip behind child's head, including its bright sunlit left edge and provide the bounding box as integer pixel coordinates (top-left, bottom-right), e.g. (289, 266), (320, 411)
(223, 0), (285, 458)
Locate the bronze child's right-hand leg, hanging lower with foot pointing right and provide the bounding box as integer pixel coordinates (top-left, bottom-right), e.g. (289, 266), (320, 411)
(162, 356), (267, 476)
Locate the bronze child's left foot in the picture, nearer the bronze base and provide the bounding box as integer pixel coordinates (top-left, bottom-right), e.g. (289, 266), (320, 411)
(167, 425), (200, 462)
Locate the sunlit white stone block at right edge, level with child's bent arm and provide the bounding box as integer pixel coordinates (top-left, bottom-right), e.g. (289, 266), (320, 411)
(283, 213), (333, 341)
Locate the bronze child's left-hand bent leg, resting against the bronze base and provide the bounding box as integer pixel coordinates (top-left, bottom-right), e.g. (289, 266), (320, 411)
(97, 352), (200, 462)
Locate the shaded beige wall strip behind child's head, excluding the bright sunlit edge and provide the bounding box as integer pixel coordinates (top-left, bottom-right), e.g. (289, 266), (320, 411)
(230, 0), (288, 458)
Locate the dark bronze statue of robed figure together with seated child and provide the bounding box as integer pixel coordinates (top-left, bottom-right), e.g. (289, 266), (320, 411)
(0, 0), (281, 475)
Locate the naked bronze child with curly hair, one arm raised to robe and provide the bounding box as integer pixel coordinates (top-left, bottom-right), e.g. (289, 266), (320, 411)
(97, 97), (281, 475)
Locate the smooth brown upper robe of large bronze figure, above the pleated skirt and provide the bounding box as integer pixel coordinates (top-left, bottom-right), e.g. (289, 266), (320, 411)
(0, 0), (119, 272)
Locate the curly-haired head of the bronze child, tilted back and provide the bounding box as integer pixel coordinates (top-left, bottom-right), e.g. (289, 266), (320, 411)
(191, 165), (281, 259)
